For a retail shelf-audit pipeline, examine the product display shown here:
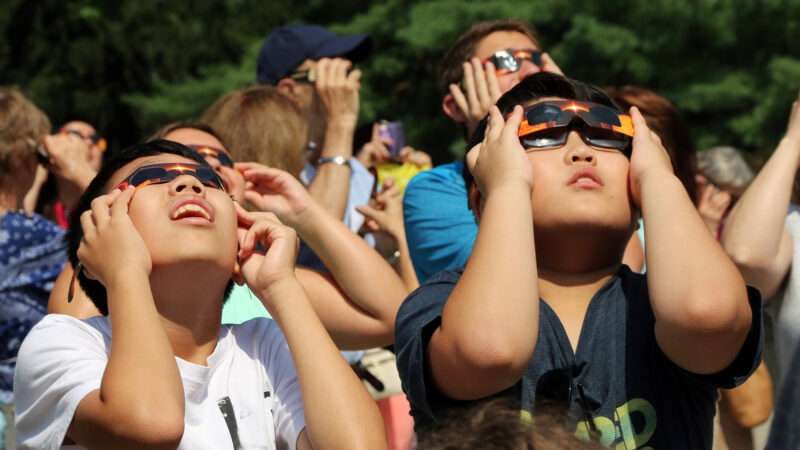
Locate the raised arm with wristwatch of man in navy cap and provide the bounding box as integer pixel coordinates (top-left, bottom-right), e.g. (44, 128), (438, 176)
(308, 58), (361, 220)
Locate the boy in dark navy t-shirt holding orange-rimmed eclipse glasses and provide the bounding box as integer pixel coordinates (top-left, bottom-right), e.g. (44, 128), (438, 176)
(395, 73), (762, 449)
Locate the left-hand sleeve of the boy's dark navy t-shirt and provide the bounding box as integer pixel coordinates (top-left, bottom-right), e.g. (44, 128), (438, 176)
(395, 272), (458, 426)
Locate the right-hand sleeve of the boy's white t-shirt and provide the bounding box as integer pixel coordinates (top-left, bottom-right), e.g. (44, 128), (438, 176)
(259, 321), (306, 450)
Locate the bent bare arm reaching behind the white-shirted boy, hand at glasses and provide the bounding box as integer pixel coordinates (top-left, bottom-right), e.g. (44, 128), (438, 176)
(236, 163), (408, 348)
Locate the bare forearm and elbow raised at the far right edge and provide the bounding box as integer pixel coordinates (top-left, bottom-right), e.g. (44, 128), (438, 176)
(722, 138), (800, 268)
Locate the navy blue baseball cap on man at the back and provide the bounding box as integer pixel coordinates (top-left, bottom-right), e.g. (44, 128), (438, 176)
(256, 25), (372, 85)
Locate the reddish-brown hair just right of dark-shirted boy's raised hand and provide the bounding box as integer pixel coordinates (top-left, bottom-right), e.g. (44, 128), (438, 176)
(606, 86), (697, 202)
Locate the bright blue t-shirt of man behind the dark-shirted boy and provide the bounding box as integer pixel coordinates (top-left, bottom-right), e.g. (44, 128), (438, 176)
(403, 161), (478, 283)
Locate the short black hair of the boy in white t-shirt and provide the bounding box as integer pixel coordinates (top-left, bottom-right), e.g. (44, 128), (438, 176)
(65, 139), (233, 316)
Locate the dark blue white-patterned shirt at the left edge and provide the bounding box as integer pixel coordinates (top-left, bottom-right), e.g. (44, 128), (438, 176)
(0, 212), (67, 403)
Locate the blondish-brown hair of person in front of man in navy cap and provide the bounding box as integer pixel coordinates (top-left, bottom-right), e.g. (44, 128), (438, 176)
(202, 86), (308, 176)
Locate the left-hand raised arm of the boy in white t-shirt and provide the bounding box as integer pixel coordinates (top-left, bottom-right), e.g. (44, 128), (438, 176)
(67, 187), (184, 449)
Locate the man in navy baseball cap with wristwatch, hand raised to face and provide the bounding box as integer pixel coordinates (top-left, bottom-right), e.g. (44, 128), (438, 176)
(256, 25), (374, 231)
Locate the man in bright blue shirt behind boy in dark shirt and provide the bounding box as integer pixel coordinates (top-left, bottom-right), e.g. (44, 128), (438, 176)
(403, 20), (561, 282)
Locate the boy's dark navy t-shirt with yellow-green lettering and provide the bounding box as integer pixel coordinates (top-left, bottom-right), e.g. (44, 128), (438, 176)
(395, 266), (763, 450)
